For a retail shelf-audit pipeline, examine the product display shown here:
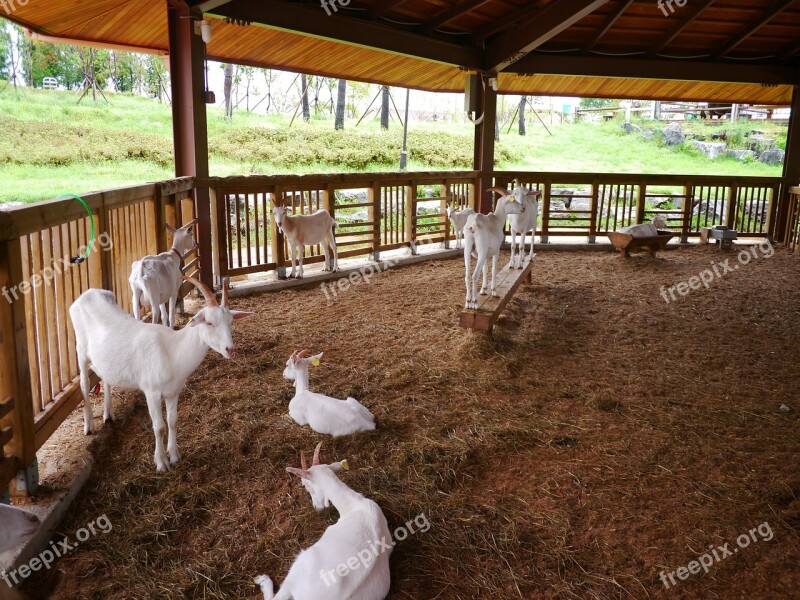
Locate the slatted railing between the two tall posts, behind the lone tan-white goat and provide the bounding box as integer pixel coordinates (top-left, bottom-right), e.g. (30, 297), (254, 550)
(205, 172), (476, 277)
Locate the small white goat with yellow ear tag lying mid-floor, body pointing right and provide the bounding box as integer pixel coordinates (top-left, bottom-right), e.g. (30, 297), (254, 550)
(283, 350), (375, 437)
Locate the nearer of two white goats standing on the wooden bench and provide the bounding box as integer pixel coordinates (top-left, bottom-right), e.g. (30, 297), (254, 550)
(464, 188), (525, 308)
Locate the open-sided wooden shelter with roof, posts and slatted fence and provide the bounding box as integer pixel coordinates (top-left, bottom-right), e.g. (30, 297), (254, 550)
(0, 0), (800, 494)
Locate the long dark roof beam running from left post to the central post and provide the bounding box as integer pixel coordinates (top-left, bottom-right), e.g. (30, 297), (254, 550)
(208, 0), (483, 69)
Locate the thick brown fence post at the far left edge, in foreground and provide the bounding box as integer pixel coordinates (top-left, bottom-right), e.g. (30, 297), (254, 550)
(0, 239), (39, 496)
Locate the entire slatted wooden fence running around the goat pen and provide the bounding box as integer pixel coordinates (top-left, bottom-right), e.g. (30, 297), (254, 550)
(0, 171), (788, 495)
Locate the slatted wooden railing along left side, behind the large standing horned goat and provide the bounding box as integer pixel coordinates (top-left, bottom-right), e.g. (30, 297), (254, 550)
(0, 178), (198, 495)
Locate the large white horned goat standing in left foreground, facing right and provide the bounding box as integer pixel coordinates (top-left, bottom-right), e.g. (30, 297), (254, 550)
(69, 277), (252, 471)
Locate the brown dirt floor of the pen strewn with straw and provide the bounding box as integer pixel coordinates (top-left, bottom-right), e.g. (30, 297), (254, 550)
(17, 246), (800, 600)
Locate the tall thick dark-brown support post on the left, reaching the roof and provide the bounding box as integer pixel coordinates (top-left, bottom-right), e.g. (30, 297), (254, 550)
(167, 4), (214, 286)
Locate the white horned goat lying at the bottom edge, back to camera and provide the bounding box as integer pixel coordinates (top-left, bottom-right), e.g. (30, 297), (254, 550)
(255, 443), (393, 600)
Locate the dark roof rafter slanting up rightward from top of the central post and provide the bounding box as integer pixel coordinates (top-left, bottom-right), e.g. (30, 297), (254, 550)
(486, 0), (609, 72)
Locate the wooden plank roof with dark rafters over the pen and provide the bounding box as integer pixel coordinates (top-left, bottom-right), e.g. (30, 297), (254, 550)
(10, 0), (800, 104)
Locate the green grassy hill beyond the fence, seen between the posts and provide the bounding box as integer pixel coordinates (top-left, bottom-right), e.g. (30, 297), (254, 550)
(0, 88), (786, 202)
